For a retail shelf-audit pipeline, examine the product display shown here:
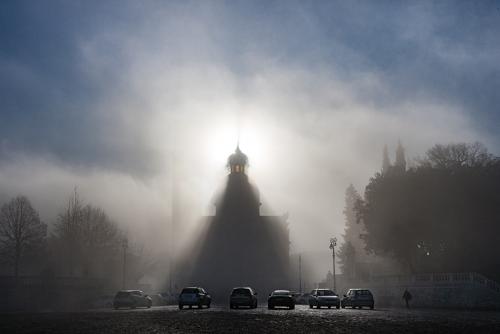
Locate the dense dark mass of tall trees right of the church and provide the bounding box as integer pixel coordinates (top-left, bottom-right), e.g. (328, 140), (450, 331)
(338, 143), (500, 280)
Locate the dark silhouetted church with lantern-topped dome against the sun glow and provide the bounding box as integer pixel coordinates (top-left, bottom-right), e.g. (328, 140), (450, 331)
(186, 146), (290, 299)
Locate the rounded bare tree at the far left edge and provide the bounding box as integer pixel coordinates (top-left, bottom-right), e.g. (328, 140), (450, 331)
(0, 196), (47, 280)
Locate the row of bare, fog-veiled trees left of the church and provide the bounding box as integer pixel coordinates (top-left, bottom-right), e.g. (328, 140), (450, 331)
(0, 190), (147, 286)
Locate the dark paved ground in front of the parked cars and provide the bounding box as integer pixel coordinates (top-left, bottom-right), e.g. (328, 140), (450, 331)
(0, 305), (500, 333)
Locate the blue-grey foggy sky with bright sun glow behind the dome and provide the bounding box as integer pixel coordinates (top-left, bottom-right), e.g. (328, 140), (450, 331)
(0, 1), (500, 251)
